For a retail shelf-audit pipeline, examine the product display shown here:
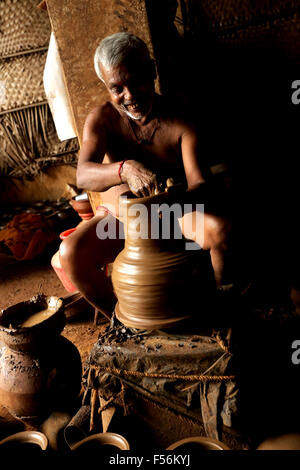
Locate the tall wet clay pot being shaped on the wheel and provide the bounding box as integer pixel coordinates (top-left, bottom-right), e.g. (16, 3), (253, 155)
(112, 192), (195, 329)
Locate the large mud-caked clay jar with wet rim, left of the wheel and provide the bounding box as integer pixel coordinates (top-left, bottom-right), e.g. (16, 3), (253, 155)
(0, 295), (81, 418)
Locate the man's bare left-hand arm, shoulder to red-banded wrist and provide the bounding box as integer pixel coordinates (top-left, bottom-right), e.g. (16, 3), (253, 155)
(77, 108), (121, 191)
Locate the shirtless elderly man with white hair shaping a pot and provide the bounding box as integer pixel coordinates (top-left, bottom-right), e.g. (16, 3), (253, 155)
(60, 32), (229, 313)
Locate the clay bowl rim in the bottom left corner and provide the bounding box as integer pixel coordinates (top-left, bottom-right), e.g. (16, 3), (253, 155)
(0, 431), (48, 457)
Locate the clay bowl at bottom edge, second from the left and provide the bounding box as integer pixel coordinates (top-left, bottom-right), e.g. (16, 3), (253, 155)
(71, 432), (130, 456)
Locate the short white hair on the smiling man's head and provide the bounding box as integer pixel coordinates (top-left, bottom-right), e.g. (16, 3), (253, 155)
(94, 32), (150, 82)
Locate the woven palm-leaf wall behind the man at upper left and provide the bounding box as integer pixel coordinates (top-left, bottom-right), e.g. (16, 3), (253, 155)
(0, 0), (78, 178)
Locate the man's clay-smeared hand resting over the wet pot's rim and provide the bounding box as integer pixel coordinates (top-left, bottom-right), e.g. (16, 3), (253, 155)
(120, 160), (159, 197)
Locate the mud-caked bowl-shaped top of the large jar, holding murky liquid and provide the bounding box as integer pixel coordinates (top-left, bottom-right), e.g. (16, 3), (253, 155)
(0, 294), (66, 353)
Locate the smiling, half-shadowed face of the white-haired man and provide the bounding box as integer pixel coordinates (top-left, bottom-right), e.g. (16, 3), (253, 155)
(100, 58), (155, 121)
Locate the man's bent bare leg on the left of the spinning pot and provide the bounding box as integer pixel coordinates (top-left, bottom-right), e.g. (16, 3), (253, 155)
(60, 214), (124, 315)
